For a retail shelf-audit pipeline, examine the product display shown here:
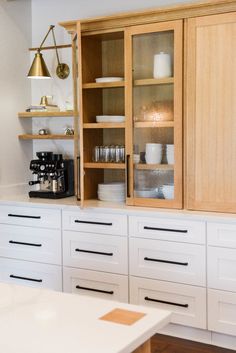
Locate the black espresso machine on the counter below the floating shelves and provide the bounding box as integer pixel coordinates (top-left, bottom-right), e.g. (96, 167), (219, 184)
(29, 152), (74, 199)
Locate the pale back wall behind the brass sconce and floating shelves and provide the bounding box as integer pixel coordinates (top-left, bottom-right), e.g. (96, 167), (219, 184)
(32, 0), (197, 156)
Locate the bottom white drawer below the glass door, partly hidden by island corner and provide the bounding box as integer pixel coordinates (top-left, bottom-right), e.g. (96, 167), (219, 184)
(130, 277), (206, 329)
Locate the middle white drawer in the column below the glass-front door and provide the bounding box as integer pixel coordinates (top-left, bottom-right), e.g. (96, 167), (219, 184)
(130, 238), (206, 286)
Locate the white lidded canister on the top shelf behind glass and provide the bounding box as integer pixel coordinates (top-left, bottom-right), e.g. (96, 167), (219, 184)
(153, 52), (172, 78)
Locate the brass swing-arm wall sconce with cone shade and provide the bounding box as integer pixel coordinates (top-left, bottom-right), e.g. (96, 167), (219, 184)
(28, 25), (70, 80)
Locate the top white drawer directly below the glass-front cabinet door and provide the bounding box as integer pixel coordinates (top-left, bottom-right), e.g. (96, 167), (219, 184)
(129, 216), (206, 244)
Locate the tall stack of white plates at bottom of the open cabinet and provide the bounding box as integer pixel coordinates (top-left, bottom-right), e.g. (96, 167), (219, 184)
(98, 182), (125, 202)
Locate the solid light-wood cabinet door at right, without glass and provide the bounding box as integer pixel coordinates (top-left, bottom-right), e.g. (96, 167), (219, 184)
(186, 13), (236, 212)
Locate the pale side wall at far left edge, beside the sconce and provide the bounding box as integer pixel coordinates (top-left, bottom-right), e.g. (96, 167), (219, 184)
(0, 0), (32, 195)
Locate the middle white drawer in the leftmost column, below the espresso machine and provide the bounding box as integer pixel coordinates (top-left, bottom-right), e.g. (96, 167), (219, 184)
(0, 224), (62, 265)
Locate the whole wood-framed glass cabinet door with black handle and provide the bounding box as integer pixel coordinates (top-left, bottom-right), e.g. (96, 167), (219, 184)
(125, 21), (183, 208)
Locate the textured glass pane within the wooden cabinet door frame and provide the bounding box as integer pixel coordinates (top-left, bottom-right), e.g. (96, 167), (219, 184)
(133, 31), (175, 200)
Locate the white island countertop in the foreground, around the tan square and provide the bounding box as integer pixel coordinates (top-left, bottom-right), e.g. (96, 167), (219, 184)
(0, 284), (171, 353)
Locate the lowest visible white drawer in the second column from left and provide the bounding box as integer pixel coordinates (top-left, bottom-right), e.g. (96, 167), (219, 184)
(63, 267), (128, 303)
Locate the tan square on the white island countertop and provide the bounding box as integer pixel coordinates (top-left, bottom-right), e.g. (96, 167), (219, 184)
(99, 309), (146, 325)
